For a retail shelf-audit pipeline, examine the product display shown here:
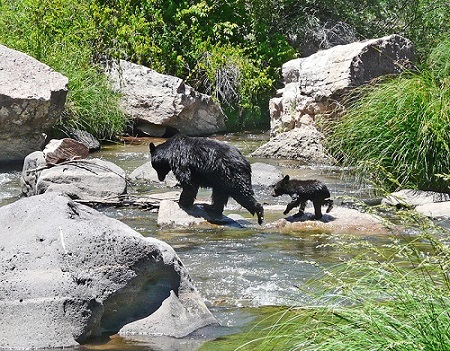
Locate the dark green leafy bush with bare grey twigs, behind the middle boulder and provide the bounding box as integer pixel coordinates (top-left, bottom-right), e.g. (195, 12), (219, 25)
(92, 0), (295, 130)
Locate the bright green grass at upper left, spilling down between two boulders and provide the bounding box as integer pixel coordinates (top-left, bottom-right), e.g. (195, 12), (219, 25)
(0, 0), (128, 139)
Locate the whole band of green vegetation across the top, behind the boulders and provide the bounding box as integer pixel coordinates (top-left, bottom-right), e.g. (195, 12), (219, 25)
(0, 0), (450, 139)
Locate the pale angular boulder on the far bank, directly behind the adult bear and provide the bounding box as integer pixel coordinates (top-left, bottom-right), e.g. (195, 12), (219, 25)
(107, 60), (226, 137)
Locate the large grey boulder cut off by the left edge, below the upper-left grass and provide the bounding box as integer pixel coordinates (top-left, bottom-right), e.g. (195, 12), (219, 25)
(0, 45), (68, 162)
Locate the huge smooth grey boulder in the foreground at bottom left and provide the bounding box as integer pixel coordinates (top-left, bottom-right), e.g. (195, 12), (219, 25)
(0, 193), (216, 349)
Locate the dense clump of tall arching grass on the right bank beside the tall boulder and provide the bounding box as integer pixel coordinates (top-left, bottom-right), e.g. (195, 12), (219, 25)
(327, 41), (450, 192)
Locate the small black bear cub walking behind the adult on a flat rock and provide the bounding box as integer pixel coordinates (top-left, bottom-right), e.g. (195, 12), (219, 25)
(272, 175), (333, 219)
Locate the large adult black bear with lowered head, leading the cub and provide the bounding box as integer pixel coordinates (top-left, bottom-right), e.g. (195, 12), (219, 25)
(150, 134), (264, 224)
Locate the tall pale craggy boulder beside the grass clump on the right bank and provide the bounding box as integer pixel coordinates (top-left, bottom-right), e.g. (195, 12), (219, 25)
(255, 35), (414, 163)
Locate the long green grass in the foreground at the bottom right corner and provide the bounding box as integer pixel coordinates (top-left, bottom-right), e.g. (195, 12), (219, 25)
(243, 236), (450, 351)
